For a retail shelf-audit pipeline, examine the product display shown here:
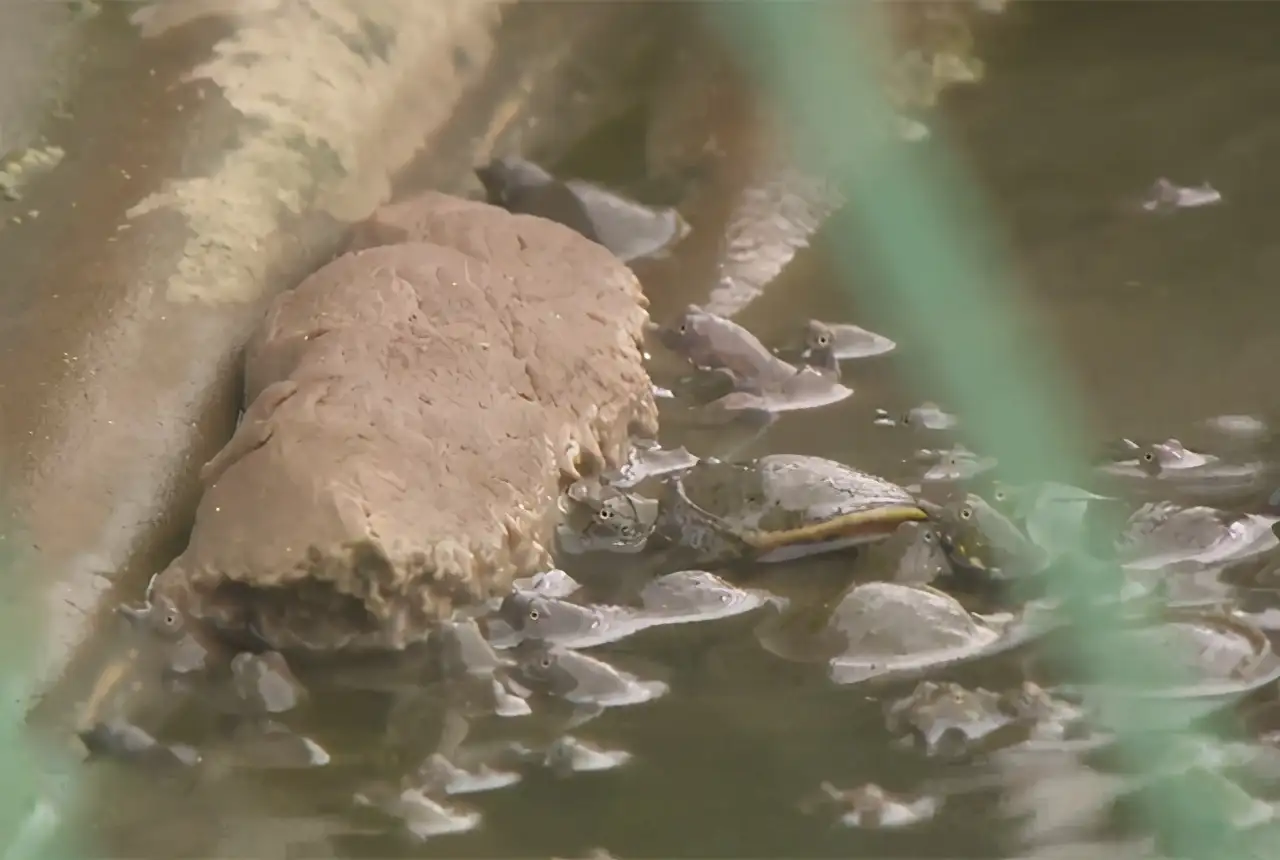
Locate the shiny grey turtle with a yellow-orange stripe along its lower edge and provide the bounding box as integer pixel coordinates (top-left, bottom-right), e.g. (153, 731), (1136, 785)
(658, 454), (927, 563)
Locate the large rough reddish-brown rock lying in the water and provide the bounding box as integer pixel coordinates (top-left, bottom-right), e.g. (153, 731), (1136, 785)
(156, 193), (657, 650)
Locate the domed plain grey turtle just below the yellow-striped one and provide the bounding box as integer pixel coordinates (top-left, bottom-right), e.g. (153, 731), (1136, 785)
(756, 582), (1029, 683)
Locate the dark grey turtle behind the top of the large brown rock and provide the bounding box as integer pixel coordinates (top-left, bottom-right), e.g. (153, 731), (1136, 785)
(476, 157), (689, 262)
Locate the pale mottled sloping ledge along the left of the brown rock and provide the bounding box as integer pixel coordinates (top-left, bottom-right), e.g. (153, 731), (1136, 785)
(0, 0), (658, 713)
